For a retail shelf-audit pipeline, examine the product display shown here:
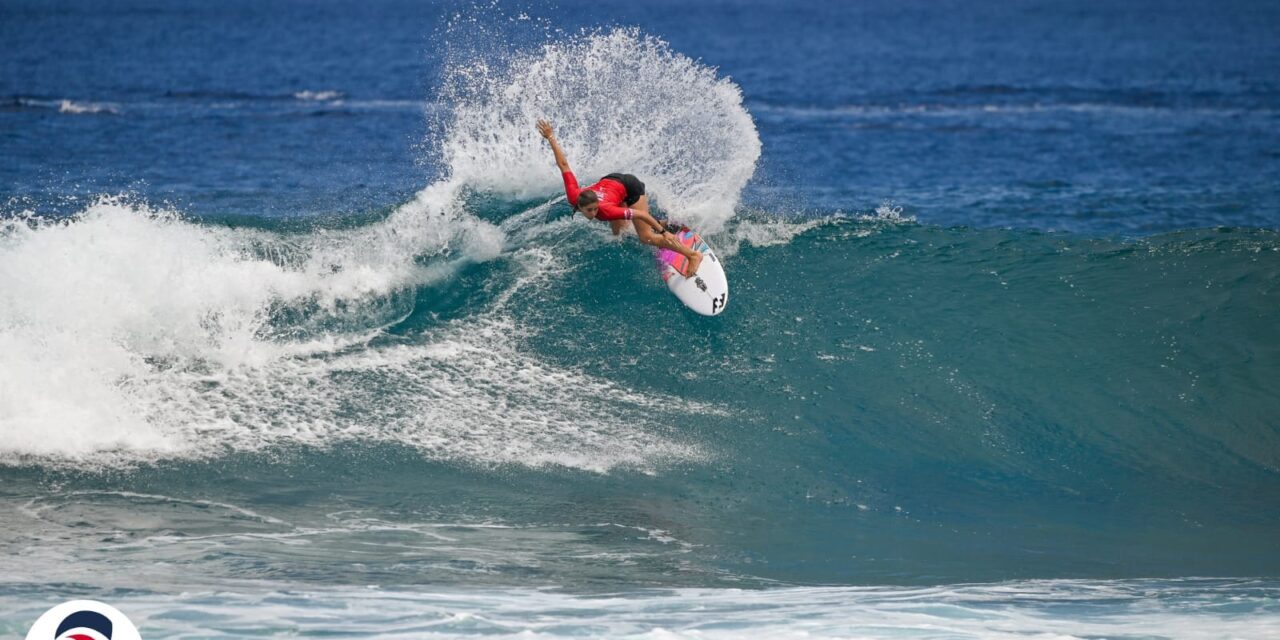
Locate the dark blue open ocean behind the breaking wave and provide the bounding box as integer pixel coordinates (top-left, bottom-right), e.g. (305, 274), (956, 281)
(0, 0), (1280, 234)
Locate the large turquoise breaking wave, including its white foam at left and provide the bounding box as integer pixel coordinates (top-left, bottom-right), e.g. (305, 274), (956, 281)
(0, 200), (1280, 585)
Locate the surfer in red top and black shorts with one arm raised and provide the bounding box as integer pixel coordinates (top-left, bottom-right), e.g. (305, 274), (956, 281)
(538, 120), (703, 278)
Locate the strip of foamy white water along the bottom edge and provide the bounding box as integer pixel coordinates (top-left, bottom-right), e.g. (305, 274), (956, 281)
(2, 580), (1280, 639)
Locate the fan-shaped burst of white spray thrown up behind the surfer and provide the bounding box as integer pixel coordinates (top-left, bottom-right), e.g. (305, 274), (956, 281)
(434, 29), (760, 233)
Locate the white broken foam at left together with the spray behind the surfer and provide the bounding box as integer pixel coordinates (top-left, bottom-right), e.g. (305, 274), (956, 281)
(0, 31), (759, 470)
